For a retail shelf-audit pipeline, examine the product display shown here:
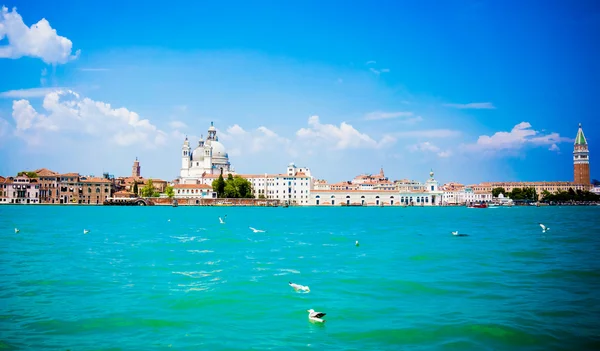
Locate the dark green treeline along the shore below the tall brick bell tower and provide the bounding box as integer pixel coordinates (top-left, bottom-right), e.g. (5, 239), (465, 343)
(492, 188), (600, 202)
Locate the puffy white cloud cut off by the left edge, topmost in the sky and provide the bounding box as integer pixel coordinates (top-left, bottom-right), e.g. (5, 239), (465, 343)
(0, 6), (79, 64)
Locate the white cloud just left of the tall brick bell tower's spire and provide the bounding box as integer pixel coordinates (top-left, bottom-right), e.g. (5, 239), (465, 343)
(464, 122), (571, 151)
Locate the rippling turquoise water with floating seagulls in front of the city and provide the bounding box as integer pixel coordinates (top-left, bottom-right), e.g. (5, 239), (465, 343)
(0, 206), (600, 350)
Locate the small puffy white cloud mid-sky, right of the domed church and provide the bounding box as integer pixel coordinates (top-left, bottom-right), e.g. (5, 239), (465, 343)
(296, 116), (396, 150)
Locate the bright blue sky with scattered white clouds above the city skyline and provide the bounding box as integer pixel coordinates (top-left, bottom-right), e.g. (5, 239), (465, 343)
(0, 1), (600, 183)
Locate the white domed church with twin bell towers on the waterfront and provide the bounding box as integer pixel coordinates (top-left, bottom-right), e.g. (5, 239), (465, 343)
(180, 122), (234, 184)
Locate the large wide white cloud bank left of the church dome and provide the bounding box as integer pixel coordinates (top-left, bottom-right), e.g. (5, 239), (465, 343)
(12, 90), (166, 148)
